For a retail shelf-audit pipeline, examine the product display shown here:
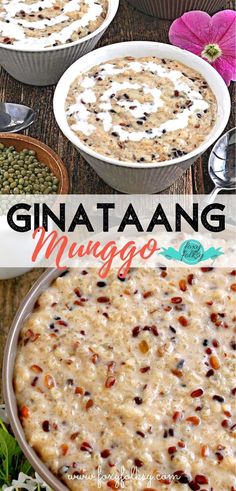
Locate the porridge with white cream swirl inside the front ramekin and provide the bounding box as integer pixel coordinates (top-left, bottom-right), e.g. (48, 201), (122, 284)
(65, 57), (217, 162)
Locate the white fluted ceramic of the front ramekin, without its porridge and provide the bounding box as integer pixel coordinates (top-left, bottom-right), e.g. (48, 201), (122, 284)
(53, 41), (231, 194)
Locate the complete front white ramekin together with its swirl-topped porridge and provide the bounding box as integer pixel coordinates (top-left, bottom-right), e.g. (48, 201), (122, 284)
(54, 41), (231, 194)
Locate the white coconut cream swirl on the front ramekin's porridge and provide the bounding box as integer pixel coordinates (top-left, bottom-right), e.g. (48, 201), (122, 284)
(67, 61), (209, 142)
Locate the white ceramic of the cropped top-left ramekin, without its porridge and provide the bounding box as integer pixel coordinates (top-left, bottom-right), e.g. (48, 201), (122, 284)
(0, 0), (119, 86)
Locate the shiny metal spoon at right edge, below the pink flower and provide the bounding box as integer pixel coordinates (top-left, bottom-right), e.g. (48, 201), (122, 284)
(207, 128), (236, 204)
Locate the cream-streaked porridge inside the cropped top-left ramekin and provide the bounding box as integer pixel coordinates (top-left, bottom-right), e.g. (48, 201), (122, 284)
(0, 0), (108, 48)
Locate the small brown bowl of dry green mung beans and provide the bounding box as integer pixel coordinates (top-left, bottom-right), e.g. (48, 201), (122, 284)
(0, 133), (69, 195)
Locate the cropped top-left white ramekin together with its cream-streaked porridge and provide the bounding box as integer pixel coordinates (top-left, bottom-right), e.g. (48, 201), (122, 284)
(0, 0), (119, 86)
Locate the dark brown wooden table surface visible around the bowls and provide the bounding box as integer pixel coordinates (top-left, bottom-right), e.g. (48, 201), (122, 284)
(0, 0), (235, 402)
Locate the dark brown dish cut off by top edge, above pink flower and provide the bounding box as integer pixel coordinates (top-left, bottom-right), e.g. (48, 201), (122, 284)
(128, 0), (226, 19)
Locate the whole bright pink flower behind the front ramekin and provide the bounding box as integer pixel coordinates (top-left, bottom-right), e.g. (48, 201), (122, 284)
(169, 10), (236, 85)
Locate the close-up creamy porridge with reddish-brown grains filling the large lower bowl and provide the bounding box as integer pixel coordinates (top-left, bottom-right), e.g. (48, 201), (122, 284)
(14, 268), (236, 491)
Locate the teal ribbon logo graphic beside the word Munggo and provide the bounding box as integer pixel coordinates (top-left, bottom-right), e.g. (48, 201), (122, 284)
(160, 239), (224, 265)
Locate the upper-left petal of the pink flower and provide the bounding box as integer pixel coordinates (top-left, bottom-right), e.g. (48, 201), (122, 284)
(169, 10), (211, 54)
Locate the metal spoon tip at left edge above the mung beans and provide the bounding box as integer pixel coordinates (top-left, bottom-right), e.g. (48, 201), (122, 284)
(0, 102), (35, 133)
